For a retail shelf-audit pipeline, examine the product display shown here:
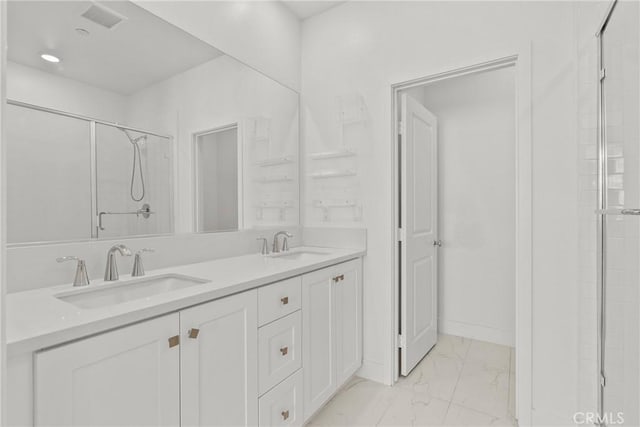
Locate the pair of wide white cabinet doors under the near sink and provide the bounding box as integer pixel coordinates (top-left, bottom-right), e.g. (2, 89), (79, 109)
(34, 290), (258, 426)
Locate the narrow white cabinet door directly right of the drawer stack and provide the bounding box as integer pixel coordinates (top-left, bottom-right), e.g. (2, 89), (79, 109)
(302, 268), (337, 419)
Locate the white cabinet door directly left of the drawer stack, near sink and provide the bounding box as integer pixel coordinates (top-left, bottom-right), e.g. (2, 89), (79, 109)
(180, 290), (258, 426)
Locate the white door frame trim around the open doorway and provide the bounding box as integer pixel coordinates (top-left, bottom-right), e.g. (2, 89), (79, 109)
(390, 49), (533, 426)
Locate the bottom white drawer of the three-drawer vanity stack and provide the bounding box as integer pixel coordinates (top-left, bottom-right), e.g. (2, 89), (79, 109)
(259, 369), (304, 427)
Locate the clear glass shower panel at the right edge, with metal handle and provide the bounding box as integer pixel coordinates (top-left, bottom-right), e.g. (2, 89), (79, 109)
(601, 1), (640, 426)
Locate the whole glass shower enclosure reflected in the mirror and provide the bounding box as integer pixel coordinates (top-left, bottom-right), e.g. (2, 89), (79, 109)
(6, 101), (173, 244)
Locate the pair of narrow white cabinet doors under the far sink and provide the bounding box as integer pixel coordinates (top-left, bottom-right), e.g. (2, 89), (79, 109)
(302, 259), (362, 419)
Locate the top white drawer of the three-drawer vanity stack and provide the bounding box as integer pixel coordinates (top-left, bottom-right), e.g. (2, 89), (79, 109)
(258, 277), (302, 326)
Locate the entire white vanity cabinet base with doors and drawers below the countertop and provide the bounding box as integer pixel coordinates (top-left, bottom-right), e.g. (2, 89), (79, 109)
(12, 258), (362, 427)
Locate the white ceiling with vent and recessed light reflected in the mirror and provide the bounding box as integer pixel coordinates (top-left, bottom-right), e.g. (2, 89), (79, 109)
(7, 1), (223, 95)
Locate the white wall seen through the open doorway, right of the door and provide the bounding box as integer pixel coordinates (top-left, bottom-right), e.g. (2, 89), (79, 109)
(408, 67), (516, 346)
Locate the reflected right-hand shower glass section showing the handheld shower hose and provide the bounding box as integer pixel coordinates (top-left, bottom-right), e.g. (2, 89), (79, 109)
(96, 123), (173, 239)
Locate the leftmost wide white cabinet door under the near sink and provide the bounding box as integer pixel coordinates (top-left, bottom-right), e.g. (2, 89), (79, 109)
(35, 314), (180, 426)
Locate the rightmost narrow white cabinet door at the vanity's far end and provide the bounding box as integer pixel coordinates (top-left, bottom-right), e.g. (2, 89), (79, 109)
(334, 259), (362, 387)
